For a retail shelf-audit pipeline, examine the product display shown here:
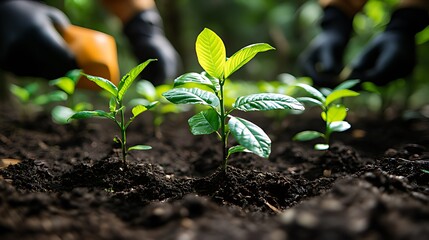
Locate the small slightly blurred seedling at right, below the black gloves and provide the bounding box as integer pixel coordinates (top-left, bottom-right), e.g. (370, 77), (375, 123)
(293, 80), (359, 150)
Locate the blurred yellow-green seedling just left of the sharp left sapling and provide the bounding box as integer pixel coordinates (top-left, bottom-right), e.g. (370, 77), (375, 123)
(49, 69), (93, 124)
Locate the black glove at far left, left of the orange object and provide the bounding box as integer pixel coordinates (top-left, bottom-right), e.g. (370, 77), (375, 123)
(0, 0), (77, 79)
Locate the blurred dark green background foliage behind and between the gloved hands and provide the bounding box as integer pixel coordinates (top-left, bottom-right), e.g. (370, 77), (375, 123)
(42, 0), (429, 117)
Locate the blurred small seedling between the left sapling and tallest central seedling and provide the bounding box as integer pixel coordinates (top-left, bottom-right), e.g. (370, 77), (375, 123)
(129, 80), (189, 139)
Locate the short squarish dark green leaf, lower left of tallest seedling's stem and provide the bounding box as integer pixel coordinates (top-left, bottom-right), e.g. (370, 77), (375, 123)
(188, 108), (221, 135)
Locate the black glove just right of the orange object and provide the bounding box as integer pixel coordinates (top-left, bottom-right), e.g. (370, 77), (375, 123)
(124, 8), (180, 85)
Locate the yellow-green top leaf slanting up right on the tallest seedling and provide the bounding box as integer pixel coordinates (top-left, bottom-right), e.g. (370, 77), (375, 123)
(224, 43), (275, 78)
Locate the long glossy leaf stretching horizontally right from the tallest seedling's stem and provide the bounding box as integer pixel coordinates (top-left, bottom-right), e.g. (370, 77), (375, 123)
(232, 93), (304, 112)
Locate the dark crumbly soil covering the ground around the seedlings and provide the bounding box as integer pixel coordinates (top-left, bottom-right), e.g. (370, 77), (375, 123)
(0, 98), (429, 240)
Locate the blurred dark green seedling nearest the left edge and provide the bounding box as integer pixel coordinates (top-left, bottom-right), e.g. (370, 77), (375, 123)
(9, 81), (68, 119)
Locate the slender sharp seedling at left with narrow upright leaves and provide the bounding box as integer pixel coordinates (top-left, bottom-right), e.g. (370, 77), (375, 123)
(70, 59), (157, 165)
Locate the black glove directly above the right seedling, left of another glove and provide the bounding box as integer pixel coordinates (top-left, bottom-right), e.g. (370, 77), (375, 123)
(300, 6), (353, 87)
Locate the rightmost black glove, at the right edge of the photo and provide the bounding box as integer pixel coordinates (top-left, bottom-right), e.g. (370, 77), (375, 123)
(350, 8), (429, 85)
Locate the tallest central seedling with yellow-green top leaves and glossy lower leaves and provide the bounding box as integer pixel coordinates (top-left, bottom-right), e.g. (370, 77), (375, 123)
(163, 28), (304, 171)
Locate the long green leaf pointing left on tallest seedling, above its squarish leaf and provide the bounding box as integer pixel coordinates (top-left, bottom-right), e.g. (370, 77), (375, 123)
(162, 88), (220, 107)
